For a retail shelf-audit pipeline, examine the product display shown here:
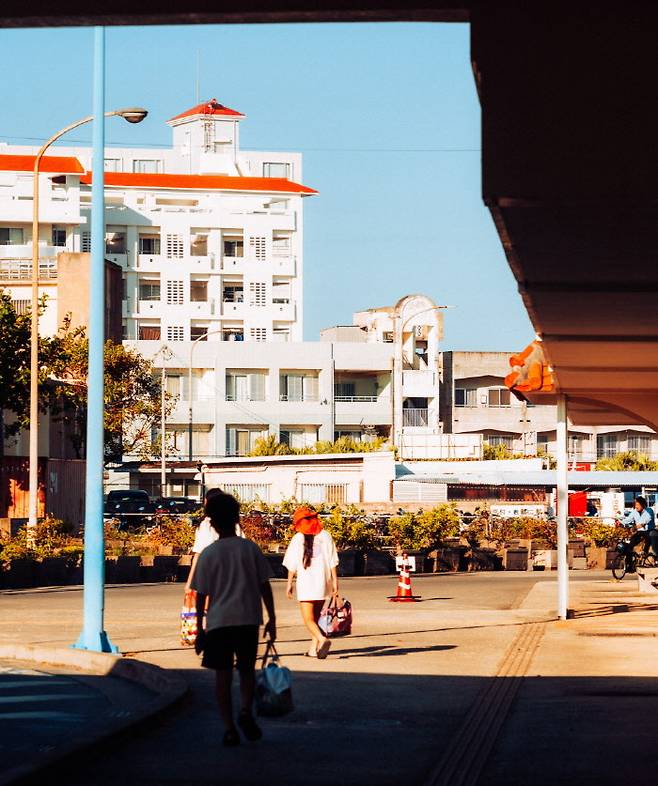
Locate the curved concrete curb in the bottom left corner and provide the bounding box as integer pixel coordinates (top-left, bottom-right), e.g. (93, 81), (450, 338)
(0, 644), (188, 786)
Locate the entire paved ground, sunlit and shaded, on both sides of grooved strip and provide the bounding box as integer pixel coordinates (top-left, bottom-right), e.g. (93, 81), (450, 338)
(5, 572), (658, 786)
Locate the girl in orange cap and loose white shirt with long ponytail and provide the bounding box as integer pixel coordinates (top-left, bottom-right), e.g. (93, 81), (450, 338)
(283, 507), (338, 658)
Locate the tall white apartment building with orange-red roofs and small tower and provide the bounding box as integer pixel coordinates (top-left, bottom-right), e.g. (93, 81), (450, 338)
(0, 99), (316, 343)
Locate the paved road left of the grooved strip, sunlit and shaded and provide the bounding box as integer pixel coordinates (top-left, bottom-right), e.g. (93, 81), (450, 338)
(0, 572), (592, 786)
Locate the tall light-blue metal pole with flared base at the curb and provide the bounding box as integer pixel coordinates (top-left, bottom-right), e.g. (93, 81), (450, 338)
(74, 27), (118, 652)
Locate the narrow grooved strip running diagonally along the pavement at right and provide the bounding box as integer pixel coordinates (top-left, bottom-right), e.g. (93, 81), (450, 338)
(425, 622), (545, 786)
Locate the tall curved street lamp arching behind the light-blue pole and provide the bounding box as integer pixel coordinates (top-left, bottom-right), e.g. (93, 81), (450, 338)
(28, 107), (148, 533)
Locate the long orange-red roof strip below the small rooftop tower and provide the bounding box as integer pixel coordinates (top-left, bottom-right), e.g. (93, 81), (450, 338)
(80, 172), (317, 194)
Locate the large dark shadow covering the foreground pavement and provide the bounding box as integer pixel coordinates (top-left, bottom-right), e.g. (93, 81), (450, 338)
(11, 664), (658, 786)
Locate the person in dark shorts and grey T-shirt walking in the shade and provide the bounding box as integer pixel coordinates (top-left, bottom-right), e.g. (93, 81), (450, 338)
(192, 492), (276, 746)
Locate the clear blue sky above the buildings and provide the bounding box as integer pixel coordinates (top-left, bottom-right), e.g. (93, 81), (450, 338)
(0, 24), (533, 350)
